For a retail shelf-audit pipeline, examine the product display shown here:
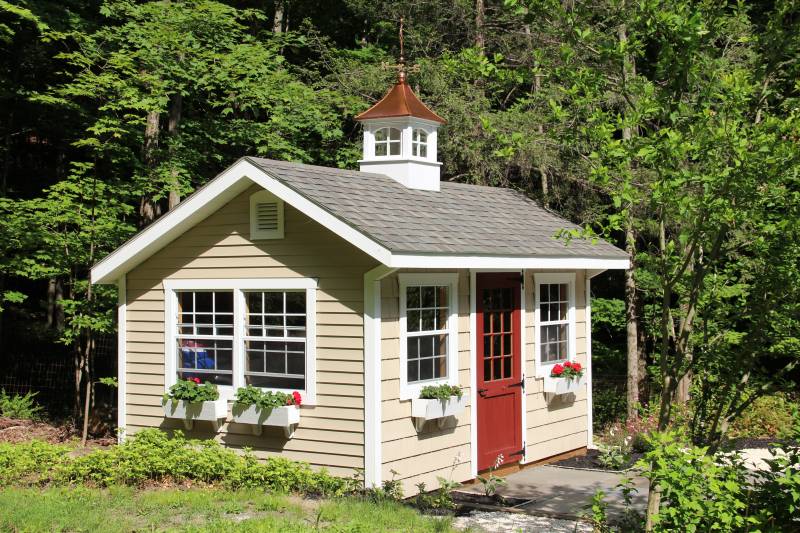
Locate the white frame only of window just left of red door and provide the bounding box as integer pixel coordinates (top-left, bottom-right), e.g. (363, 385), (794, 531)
(398, 273), (459, 400)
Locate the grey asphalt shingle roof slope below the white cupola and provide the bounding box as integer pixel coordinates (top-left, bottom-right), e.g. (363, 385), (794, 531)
(248, 157), (627, 259)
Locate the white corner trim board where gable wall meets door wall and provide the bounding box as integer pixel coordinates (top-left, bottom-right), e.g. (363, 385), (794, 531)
(364, 265), (395, 487)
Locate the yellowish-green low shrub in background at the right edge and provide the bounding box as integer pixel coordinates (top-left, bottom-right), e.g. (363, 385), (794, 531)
(728, 394), (798, 439)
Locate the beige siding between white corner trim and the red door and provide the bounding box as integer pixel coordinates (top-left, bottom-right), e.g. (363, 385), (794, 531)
(381, 270), (472, 496)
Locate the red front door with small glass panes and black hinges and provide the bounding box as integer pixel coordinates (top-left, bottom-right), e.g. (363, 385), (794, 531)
(475, 272), (522, 470)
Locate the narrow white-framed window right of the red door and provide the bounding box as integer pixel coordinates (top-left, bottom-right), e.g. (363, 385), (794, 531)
(536, 274), (575, 373)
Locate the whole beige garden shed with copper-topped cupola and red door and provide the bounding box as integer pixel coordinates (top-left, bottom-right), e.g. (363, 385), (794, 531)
(91, 71), (629, 495)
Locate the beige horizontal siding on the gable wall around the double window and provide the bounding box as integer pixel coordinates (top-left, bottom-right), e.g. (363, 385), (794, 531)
(125, 186), (376, 475)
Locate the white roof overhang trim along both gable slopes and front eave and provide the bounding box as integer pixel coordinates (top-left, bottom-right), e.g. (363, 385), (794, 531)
(91, 158), (629, 283)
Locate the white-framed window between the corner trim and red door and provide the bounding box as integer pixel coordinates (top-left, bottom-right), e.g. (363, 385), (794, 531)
(400, 274), (458, 399)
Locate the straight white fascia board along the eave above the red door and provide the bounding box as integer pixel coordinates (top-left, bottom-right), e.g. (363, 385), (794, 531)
(389, 253), (630, 270)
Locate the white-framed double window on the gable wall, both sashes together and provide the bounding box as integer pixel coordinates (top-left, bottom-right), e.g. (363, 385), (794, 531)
(164, 278), (316, 404)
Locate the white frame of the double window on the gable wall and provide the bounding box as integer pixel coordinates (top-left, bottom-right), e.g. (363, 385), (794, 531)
(163, 278), (317, 405)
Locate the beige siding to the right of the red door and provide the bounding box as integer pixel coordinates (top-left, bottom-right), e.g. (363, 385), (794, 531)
(525, 270), (588, 462)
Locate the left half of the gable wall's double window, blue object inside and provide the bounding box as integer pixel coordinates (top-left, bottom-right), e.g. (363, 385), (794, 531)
(176, 291), (233, 385)
